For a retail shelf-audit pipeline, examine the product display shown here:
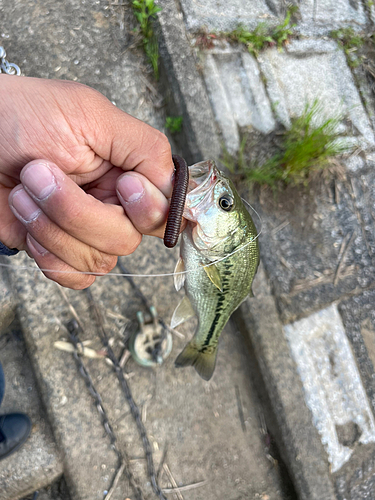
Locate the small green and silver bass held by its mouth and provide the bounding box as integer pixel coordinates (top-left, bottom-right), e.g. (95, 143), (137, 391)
(171, 160), (259, 380)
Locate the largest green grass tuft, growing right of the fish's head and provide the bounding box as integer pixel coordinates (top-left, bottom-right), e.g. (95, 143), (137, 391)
(226, 101), (351, 189)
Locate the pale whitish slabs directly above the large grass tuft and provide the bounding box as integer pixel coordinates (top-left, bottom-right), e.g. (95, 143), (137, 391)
(198, 39), (375, 154)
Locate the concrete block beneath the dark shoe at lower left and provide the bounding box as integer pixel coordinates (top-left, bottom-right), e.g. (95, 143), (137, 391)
(0, 321), (63, 500)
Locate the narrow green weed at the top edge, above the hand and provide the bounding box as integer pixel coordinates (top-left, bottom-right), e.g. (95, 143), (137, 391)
(132, 0), (162, 79)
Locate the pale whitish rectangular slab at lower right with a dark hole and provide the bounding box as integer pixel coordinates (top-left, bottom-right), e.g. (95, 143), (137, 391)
(284, 305), (375, 473)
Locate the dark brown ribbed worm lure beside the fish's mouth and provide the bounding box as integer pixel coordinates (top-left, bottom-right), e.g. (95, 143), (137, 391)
(164, 155), (189, 248)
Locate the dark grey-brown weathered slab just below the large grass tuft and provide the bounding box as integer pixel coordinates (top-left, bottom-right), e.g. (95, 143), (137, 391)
(256, 174), (375, 323)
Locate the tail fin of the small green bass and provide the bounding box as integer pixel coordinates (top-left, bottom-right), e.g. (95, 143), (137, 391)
(175, 342), (217, 380)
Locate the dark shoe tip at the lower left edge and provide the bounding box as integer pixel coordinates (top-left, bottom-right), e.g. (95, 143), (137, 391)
(0, 413), (31, 460)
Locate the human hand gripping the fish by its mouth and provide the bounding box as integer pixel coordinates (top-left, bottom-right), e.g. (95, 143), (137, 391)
(0, 74), (173, 289)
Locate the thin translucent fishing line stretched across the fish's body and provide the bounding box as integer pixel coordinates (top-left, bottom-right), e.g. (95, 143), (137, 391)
(0, 198), (263, 278)
